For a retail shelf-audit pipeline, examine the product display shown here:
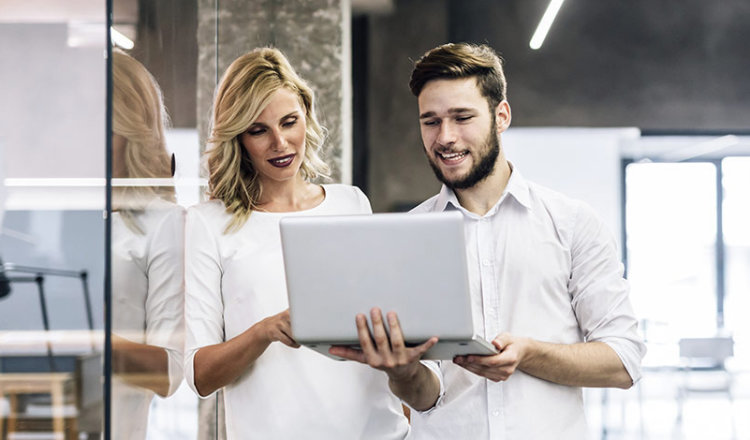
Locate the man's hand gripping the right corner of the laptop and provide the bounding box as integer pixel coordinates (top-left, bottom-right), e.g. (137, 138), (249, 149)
(453, 333), (525, 382)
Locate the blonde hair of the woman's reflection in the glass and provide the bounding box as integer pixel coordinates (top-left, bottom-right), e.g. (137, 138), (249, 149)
(112, 50), (175, 233)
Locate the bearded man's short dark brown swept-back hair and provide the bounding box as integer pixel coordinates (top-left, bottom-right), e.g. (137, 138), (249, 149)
(409, 43), (507, 111)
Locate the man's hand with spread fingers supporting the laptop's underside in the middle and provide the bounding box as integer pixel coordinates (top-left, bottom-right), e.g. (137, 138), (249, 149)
(329, 307), (438, 381)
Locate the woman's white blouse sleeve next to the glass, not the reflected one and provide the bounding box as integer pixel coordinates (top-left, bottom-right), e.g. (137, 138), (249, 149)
(184, 207), (224, 398)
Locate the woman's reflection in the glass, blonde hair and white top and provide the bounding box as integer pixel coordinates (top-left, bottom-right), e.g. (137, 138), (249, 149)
(112, 51), (184, 439)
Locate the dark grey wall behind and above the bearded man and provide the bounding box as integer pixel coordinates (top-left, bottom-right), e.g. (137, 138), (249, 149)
(362, 0), (750, 211)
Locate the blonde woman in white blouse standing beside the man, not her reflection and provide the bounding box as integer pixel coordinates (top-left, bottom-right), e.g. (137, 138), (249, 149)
(185, 48), (408, 440)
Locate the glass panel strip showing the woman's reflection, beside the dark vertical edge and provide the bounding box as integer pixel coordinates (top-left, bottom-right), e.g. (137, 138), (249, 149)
(109, 0), (203, 440)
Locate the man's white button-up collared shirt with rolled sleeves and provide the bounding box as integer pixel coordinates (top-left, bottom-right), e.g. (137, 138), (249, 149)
(409, 170), (645, 440)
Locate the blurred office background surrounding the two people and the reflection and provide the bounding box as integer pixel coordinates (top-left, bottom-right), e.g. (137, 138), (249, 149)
(0, 0), (750, 439)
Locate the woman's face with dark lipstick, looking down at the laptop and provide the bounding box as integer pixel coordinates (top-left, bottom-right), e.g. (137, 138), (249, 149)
(240, 88), (307, 185)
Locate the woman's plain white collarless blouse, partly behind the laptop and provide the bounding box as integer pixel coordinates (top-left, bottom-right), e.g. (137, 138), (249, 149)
(185, 185), (409, 440)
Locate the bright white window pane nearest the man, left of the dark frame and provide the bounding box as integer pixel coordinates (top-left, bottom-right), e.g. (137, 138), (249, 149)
(625, 162), (717, 339)
